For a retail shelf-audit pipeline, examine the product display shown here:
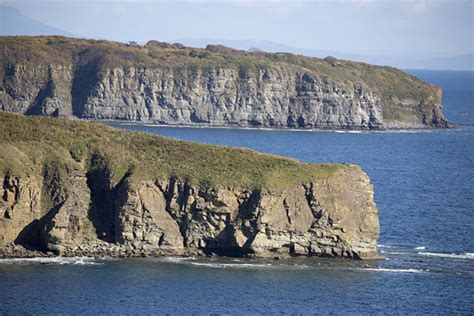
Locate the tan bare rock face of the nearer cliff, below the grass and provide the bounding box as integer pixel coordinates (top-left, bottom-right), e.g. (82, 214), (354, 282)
(0, 163), (379, 258)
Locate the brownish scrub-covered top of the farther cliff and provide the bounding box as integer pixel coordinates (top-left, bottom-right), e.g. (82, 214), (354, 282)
(0, 36), (436, 102)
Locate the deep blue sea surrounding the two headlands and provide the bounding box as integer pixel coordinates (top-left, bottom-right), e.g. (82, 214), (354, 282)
(0, 70), (474, 315)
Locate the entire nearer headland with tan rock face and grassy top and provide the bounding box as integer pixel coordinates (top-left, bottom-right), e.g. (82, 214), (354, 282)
(0, 113), (379, 258)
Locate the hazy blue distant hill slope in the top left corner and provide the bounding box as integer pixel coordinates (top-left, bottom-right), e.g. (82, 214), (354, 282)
(0, 5), (77, 37)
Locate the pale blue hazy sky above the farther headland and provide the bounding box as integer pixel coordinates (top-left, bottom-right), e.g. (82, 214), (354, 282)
(0, 0), (474, 57)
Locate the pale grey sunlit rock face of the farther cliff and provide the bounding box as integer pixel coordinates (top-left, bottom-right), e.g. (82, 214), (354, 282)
(81, 67), (383, 128)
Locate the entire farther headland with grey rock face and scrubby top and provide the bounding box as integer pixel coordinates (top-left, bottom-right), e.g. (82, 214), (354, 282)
(0, 36), (447, 129)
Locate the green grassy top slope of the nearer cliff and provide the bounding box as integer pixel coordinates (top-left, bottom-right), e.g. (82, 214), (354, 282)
(0, 113), (341, 189)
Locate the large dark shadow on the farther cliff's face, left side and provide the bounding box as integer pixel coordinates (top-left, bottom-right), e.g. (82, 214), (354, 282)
(71, 61), (99, 118)
